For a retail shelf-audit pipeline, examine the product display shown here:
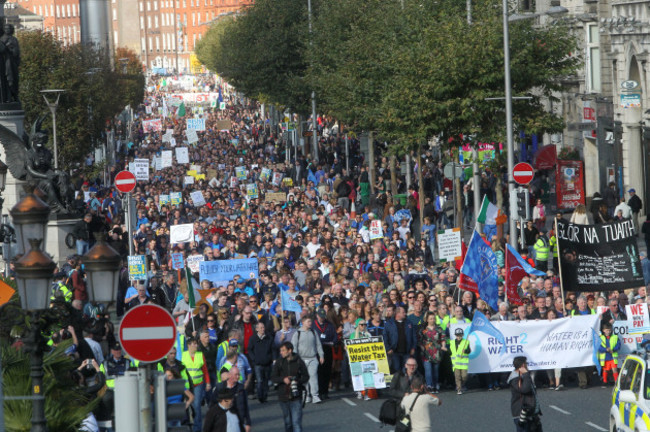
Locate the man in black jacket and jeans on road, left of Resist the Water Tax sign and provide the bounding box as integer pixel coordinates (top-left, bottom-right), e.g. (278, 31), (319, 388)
(271, 342), (309, 432)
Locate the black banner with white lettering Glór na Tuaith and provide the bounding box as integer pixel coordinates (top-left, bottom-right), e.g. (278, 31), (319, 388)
(557, 219), (645, 291)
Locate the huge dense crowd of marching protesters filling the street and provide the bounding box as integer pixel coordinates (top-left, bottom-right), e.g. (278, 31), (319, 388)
(21, 75), (650, 432)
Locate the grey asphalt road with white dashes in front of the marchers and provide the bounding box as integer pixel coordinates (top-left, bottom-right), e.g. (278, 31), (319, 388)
(244, 387), (612, 432)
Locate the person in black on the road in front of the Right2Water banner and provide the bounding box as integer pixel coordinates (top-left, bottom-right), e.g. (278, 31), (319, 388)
(508, 356), (542, 432)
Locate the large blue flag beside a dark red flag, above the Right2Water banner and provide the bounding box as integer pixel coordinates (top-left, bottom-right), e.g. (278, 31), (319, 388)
(460, 230), (499, 310)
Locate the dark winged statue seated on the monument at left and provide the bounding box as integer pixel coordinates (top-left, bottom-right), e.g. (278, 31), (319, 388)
(0, 117), (74, 214)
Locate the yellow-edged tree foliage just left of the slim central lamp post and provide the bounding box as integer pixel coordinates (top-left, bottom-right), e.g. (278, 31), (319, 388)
(196, 0), (317, 113)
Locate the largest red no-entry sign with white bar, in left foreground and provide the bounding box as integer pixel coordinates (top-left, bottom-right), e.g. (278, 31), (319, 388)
(120, 304), (176, 363)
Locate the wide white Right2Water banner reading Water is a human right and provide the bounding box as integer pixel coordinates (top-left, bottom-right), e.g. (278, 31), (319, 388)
(449, 315), (600, 373)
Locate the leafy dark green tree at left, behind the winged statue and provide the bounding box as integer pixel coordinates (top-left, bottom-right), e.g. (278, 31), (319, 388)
(18, 31), (144, 169)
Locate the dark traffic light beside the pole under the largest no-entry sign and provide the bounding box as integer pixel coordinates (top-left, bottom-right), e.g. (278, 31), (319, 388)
(154, 374), (187, 432)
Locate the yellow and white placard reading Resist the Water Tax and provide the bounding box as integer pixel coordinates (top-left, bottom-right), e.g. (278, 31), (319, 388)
(345, 336), (390, 391)
